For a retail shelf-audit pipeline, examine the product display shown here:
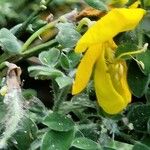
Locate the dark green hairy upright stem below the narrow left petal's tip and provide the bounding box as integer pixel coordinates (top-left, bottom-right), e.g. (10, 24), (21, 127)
(53, 86), (70, 112)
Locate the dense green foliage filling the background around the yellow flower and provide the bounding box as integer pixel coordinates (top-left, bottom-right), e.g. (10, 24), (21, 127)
(0, 0), (150, 150)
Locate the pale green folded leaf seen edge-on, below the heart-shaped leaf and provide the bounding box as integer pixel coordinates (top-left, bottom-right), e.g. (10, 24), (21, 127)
(28, 66), (64, 80)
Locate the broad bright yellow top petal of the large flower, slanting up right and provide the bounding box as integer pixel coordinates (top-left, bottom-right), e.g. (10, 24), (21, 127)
(75, 8), (145, 52)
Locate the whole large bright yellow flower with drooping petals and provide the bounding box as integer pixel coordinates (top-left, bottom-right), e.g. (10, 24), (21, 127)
(72, 8), (145, 114)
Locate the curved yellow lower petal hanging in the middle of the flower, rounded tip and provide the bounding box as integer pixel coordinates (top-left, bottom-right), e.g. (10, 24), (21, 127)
(94, 46), (127, 114)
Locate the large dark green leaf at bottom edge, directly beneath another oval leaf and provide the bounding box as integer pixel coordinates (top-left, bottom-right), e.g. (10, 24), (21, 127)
(41, 130), (74, 150)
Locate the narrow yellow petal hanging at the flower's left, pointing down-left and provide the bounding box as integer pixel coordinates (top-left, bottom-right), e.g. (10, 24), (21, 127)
(72, 44), (101, 94)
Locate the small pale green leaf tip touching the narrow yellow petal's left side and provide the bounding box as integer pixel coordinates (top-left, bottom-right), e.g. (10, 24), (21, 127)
(55, 76), (73, 89)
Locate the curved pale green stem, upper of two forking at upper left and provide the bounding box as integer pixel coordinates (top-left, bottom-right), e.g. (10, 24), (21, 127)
(21, 20), (58, 53)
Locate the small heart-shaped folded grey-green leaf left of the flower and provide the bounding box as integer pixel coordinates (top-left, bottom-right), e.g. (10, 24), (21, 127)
(39, 48), (60, 67)
